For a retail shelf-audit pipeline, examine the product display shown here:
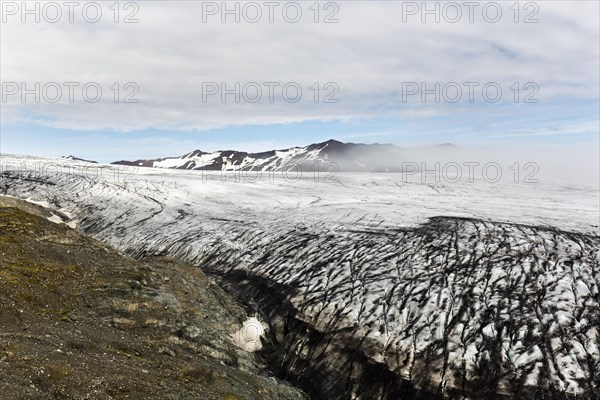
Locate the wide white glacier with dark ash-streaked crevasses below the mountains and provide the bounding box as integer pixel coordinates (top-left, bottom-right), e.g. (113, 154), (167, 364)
(0, 155), (600, 400)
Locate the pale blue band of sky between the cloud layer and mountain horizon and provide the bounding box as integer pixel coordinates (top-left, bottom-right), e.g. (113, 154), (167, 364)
(2, 100), (600, 162)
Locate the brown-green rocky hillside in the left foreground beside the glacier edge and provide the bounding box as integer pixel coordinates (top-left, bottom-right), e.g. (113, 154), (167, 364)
(0, 199), (306, 400)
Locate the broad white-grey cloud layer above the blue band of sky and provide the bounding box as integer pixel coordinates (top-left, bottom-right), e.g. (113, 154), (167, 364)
(0, 1), (600, 131)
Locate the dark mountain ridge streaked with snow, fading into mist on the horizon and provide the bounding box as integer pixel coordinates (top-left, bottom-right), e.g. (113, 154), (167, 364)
(113, 139), (446, 172)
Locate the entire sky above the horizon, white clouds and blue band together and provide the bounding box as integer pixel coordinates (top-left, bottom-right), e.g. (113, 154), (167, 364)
(0, 0), (600, 162)
